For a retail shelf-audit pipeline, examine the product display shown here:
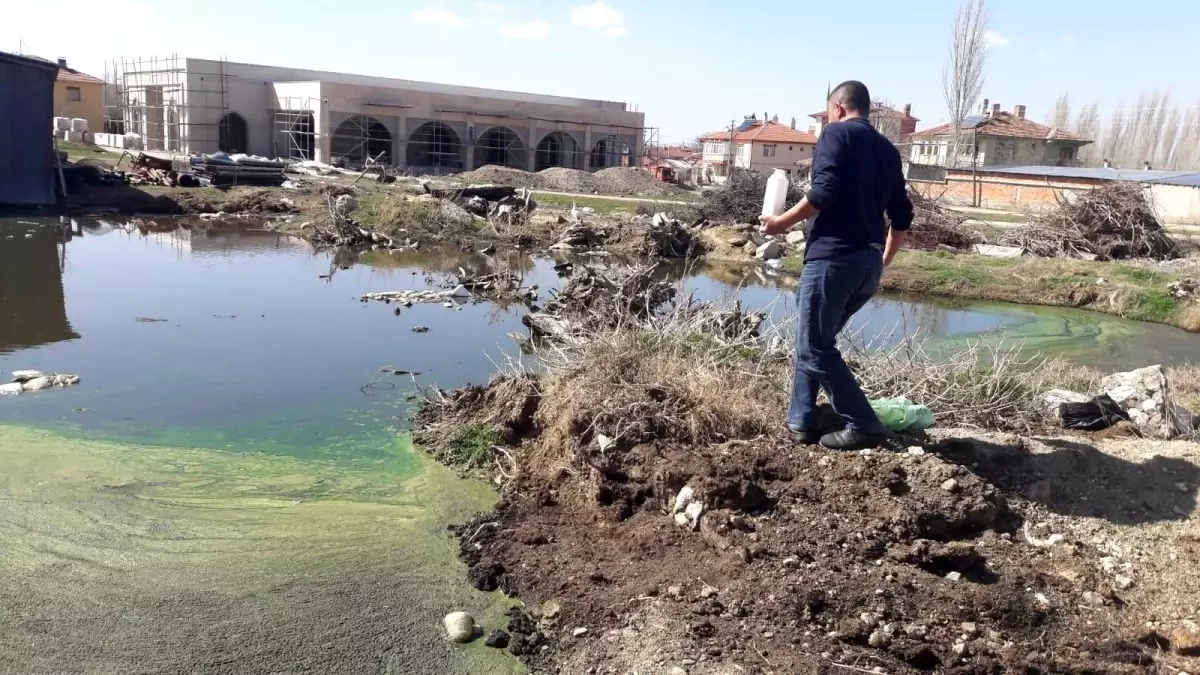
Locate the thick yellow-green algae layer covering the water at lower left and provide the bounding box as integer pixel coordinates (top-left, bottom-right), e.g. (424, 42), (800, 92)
(0, 426), (520, 673)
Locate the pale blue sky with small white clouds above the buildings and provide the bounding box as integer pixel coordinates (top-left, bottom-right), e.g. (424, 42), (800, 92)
(7, 0), (1200, 141)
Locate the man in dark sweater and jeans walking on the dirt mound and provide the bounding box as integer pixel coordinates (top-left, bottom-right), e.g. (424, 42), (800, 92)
(762, 80), (912, 450)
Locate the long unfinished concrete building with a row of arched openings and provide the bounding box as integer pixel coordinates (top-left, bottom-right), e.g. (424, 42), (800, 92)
(108, 56), (644, 172)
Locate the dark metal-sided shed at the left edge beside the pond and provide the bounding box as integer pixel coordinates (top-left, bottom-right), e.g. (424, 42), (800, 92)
(0, 52), (59, 205)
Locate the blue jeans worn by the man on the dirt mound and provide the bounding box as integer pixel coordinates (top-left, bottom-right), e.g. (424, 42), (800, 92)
(787, 249), (884, 434)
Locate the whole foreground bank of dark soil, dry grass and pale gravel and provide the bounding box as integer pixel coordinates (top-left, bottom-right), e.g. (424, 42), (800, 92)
(416, 275), (1200, 675)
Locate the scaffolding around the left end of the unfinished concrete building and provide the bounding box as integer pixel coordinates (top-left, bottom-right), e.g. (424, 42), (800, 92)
(104, 54), (229, 153)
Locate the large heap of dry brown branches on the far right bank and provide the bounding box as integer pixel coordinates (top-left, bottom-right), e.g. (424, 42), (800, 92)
(1002, 183), (1181, 261)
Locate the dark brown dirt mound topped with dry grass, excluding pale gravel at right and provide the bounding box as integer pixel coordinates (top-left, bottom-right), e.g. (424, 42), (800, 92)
(418, 324), (1185, 674)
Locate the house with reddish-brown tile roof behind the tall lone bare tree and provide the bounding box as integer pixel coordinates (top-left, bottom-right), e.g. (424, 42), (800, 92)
(908, 102), (1092, 167)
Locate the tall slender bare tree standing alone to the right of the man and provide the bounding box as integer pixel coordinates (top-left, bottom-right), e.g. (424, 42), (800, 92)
(942, 0), (989, 167)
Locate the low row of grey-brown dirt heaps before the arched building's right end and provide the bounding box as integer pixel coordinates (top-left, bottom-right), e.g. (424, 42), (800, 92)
(460, 165), (684, 197)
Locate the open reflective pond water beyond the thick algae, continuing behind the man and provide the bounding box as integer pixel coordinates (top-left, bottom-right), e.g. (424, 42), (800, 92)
(0, 214), (1195, 446)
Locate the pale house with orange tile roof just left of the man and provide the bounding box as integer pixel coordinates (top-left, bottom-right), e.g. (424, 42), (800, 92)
(700, 115), (817, 183)
